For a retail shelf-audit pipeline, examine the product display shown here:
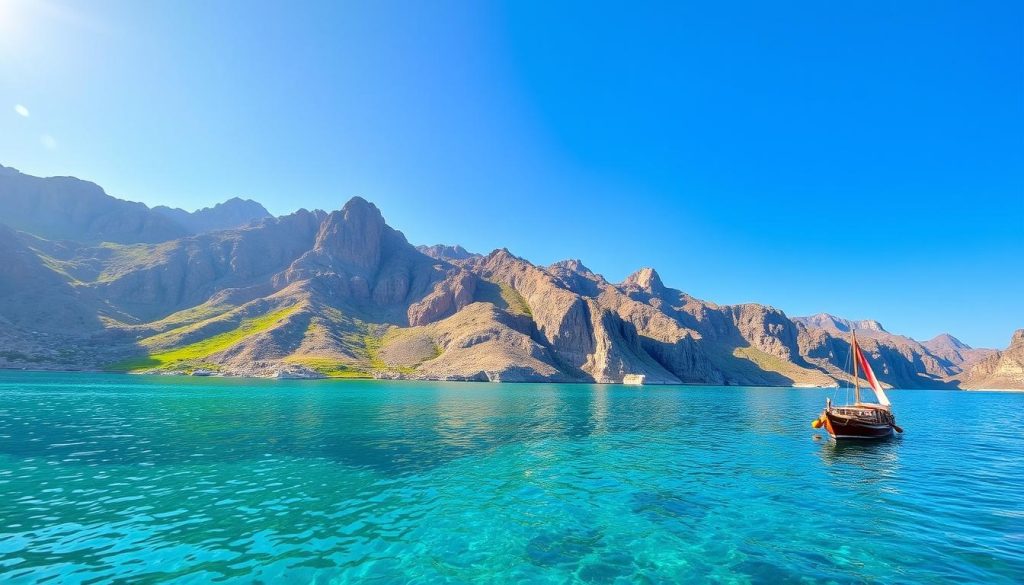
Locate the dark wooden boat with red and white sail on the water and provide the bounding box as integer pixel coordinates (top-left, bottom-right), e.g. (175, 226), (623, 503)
(811, 332), (903, 441)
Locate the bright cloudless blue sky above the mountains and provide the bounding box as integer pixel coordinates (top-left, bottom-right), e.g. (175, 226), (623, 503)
(0, 0), (1024, 347)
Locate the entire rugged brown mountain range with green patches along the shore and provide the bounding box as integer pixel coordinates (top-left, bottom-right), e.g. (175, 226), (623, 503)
(0, 167), (1024, 388)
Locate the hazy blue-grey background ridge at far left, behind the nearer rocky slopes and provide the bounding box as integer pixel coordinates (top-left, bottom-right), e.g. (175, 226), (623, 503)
(0, 165), (270, 244)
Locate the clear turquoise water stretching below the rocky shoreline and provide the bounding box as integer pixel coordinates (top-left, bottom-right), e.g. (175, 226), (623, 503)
(0, 372), (1024, 583)
